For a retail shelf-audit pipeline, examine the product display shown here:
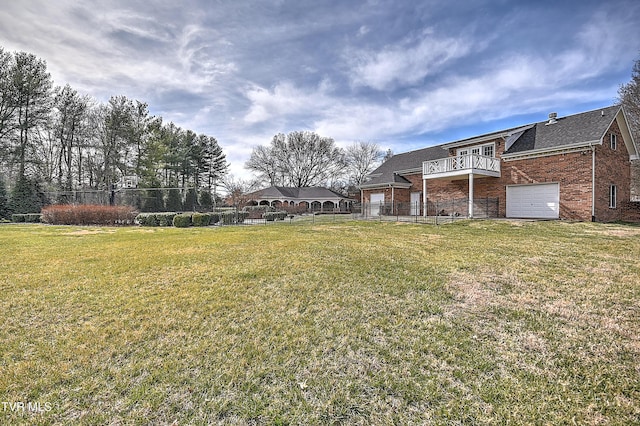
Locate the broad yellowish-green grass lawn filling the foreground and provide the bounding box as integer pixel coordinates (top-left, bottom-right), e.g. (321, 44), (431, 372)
(0, 221), (640, 425)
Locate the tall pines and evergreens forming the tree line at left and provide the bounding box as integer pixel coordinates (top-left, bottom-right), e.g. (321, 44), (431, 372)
(0, 47), (228, 217)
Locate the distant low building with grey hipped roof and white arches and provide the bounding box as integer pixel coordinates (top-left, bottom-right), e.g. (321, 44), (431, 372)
(246, 186), (353, 212)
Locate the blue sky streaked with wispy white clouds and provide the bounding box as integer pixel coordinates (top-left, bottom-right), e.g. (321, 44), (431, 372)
(0, 0), (640, 179)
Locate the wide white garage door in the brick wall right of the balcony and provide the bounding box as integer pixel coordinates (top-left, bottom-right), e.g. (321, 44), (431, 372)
(507, 183), (560, 219)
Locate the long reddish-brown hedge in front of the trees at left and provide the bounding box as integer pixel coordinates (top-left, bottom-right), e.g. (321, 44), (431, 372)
(42, 204), (137, 225)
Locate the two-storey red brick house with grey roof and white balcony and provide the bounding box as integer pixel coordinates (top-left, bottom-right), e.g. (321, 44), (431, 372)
(360, 106), (640, 222)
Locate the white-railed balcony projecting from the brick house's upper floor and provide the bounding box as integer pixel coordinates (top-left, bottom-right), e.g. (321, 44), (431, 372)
(422, 154), (500, 179)
